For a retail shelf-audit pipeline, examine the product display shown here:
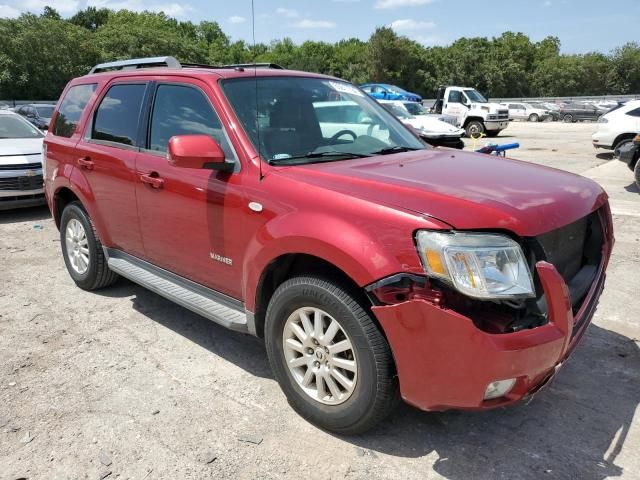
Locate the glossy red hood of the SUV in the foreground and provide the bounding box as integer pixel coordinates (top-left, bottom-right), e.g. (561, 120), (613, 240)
(277, 149), (607, 237)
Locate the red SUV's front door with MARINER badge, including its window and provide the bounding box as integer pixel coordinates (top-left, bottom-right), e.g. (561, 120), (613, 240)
(136, 80), (246, 299)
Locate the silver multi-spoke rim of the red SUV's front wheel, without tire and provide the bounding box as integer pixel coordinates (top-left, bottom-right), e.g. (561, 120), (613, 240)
(282, 307), (358, 405)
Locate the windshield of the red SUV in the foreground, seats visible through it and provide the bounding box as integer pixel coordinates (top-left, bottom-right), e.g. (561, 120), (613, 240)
(222, 77), (425, 164)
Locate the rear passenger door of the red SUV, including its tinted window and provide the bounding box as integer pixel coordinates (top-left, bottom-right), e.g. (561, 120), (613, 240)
(76, 79), (148, 255)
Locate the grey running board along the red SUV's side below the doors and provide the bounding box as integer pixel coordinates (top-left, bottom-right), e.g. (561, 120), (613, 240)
(104, 248), (250, 333)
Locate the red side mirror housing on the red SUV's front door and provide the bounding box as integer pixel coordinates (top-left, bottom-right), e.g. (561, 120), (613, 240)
(167, 135), (234, 172)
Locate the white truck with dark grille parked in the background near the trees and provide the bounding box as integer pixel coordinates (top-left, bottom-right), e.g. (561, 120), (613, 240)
(434, 87), (509, 137)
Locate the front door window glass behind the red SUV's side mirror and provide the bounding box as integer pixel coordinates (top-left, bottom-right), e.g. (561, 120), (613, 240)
(149, 84), (234, 159)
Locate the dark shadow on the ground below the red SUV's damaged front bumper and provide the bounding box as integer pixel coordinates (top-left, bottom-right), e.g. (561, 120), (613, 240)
(348, 325), (640, 480)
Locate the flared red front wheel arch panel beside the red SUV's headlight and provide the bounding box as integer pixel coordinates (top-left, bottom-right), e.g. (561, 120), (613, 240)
(243, 212), (428, 311)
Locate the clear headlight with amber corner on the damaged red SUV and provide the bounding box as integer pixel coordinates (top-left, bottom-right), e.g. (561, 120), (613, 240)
(416, 230), (535, 299)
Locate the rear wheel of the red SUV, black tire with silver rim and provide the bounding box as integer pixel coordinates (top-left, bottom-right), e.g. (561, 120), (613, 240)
(60, 202), (118, 290)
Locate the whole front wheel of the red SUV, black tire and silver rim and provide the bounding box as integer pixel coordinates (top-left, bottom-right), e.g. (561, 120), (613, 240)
(265, 277), (398, 435)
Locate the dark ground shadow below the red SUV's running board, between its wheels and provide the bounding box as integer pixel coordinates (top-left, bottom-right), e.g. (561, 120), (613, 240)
(94, 278), (273, 378)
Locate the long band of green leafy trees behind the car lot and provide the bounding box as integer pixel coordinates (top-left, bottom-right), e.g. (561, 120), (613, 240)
(0, 7), (640, 100)
